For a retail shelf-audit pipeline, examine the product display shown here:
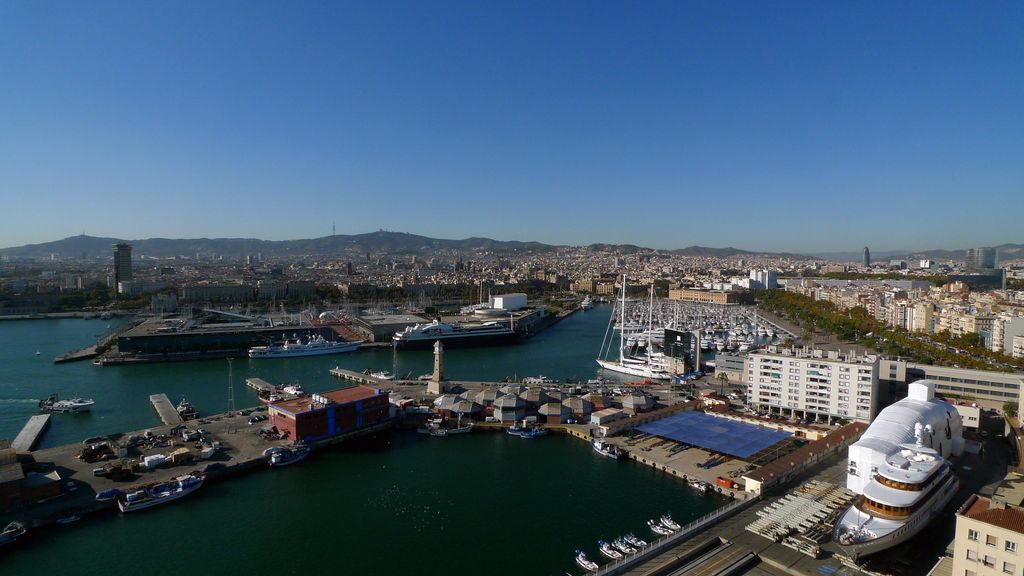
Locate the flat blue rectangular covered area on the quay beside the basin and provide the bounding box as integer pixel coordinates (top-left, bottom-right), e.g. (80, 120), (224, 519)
(637, 412), (792, 458)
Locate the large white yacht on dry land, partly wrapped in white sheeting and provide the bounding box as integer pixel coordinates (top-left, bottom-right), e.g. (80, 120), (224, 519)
(834, 380), (964, 561)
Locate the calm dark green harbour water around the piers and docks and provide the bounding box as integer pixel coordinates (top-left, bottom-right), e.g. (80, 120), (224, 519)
(0, 307), (722, 575)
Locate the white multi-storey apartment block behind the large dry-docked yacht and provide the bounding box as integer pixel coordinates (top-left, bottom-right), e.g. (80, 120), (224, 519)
(746, 346), (880, 422)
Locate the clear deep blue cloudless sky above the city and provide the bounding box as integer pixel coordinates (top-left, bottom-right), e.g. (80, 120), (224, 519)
(0, 0), (1024, 252)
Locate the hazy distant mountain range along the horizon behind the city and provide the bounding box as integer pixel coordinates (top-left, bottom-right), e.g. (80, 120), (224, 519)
(0, 231), (1024, 261)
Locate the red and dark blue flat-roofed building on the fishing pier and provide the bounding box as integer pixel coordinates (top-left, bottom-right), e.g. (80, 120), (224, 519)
(269, 386), (389, 442)
